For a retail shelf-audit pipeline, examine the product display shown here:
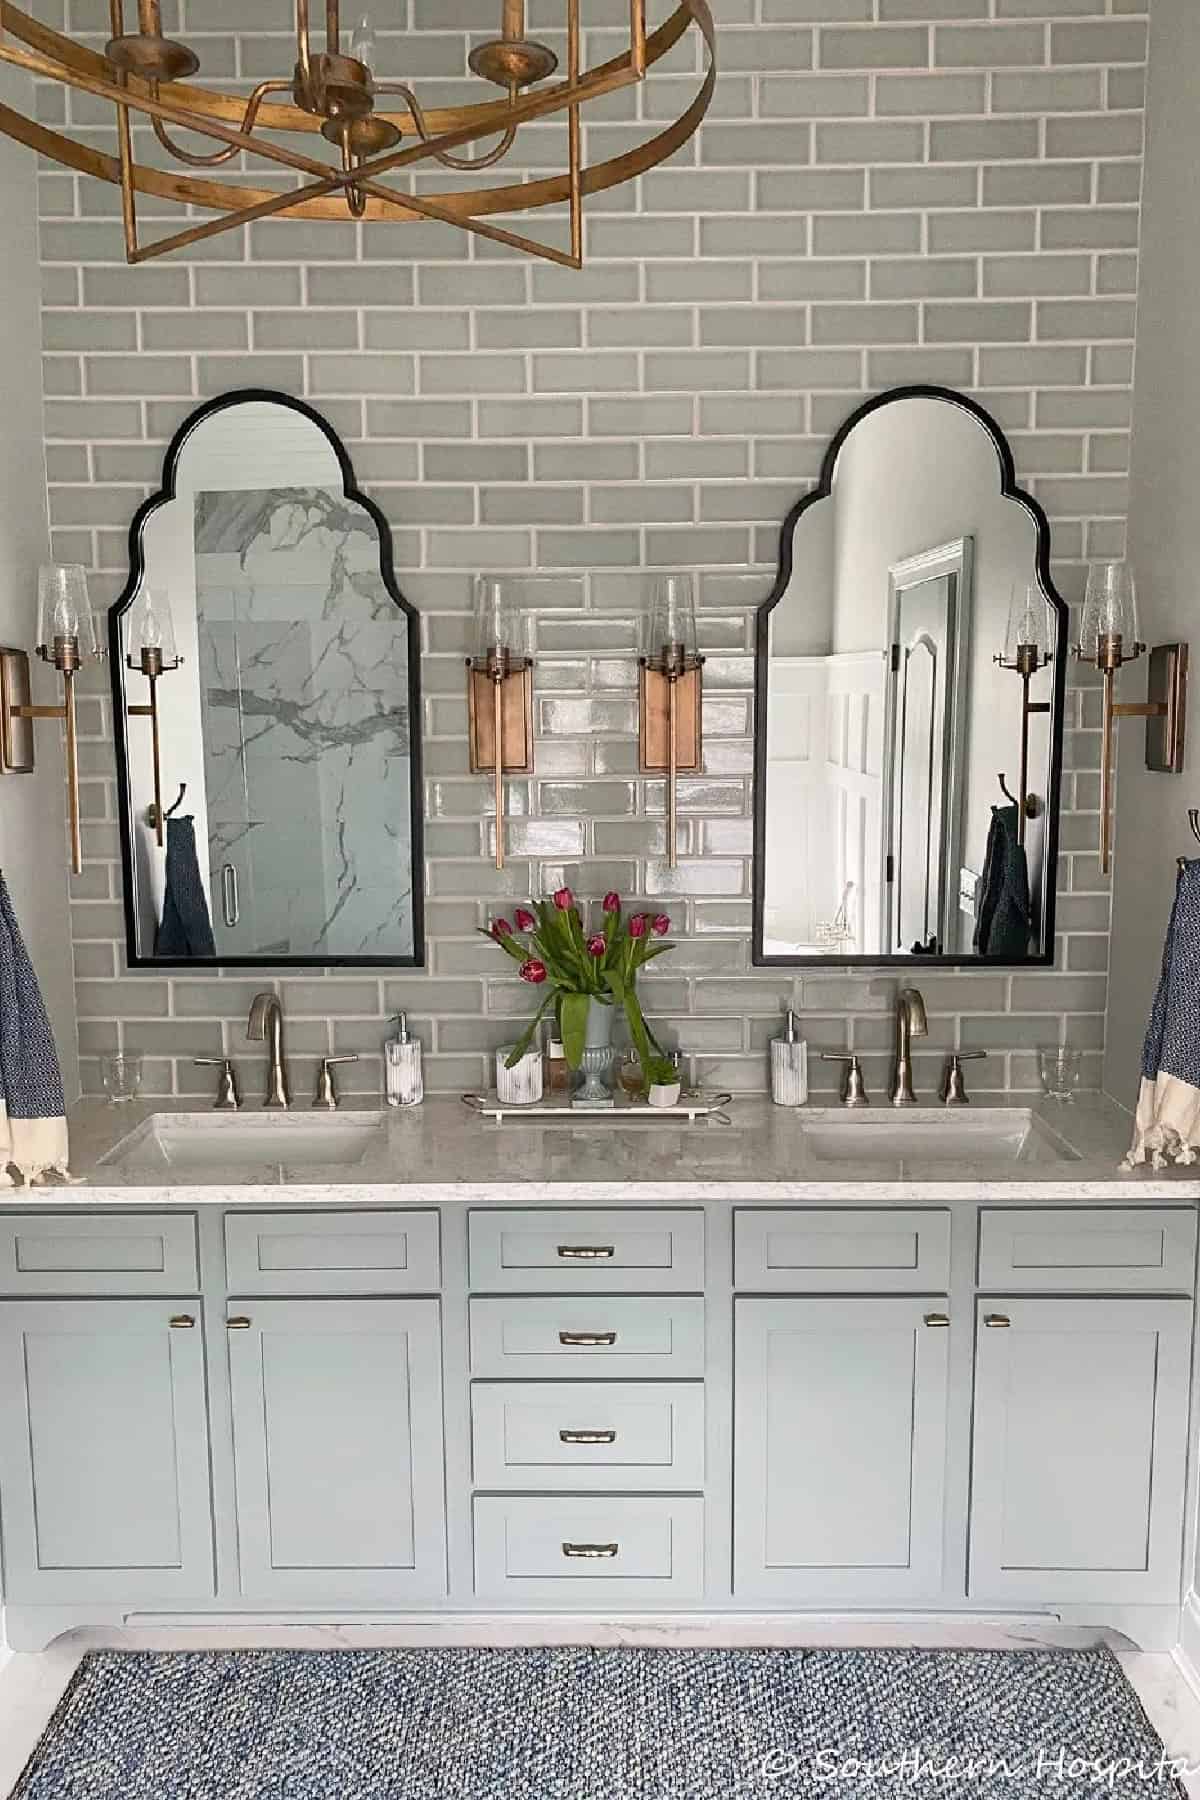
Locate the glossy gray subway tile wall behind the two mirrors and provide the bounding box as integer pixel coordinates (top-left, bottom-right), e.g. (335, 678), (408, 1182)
(30, 0), (1146, 1098)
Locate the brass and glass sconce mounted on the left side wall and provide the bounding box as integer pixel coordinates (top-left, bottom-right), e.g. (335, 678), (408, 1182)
(0, 563), (103, 875)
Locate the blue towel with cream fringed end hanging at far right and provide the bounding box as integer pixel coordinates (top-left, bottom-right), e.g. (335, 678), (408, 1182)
(1124, 862), (1200, 1168)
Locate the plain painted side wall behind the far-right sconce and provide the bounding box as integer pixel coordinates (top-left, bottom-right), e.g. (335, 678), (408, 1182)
(1105, 0), (1200, 1103)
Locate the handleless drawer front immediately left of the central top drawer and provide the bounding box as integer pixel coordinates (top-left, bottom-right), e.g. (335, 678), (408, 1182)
(225, 1213), (441, 1294)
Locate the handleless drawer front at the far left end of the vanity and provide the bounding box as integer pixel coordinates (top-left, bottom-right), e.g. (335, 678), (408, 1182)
(0, 1213), (200, 1294)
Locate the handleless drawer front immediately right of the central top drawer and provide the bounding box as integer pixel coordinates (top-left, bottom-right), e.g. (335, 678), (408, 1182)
(734, 1206), (950, 1294)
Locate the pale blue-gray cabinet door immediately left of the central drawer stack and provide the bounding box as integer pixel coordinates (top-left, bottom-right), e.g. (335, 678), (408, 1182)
(227, 1300), (446, 1606)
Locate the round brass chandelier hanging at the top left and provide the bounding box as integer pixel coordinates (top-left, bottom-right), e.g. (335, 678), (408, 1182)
(0, 0), (716, 268)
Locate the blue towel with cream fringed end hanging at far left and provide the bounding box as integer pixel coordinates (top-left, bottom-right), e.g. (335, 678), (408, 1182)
(0, 875), (68, 1188)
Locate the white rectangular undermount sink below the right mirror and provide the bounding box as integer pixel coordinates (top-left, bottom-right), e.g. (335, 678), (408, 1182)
(799, 1107), (1079, 1168)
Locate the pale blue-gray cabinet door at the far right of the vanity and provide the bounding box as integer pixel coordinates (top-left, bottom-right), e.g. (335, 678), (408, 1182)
(970, 1300), (1191, 1604)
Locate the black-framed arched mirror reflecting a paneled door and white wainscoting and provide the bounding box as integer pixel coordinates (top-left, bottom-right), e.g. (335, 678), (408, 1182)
(754, 387), (1067, 965)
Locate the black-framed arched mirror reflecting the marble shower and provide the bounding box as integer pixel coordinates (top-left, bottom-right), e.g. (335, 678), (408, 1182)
(108, 391), (425, 968)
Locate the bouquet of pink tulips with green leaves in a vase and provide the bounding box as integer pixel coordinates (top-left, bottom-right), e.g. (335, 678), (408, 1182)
(480, 887), (675, 1069)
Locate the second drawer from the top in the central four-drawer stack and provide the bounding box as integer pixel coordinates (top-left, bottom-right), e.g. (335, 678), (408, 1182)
(471, 1294), (703, 1379)
